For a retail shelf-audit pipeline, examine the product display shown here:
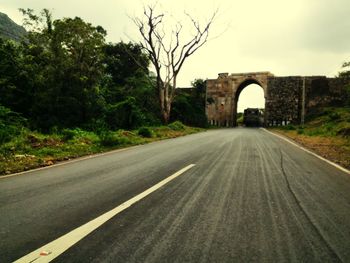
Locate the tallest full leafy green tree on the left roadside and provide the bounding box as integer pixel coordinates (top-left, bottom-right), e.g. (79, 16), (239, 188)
(52, 17), (106, 125)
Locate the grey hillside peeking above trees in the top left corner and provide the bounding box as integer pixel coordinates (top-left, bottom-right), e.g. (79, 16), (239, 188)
(0, 12), (27, 41)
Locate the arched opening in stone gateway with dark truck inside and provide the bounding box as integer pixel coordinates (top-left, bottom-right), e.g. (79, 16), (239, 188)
(233, 79), (266, 127)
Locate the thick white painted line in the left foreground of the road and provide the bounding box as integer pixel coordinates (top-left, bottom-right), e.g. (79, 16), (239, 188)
(15, 164), (195, 263)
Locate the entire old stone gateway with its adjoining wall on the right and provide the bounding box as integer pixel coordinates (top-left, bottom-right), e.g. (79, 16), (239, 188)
(206, 72), (349, 127)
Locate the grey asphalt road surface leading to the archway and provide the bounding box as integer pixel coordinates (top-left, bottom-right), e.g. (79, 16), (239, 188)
(0, 128), (350, 262)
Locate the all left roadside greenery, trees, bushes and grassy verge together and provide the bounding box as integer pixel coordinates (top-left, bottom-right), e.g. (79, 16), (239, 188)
(0, 9), (207, 175)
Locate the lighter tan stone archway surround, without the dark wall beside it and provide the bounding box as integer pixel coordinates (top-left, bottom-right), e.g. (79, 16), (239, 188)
(206, 72), (273, 127)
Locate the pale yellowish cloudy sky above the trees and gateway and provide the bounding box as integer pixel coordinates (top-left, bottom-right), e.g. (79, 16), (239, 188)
(0, 0), (350, 111)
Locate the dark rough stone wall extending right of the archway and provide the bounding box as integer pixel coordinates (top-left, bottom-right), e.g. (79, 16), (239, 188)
(265, 76), (347, 126)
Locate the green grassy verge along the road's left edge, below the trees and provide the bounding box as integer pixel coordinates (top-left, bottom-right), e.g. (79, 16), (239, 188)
(0, 122), (203, 175)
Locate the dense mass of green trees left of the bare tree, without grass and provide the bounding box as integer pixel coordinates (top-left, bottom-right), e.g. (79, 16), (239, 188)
(0, 9), (160, 132)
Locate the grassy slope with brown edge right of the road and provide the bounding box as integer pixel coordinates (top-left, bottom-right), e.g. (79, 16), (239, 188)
(271, 108), (350, 169)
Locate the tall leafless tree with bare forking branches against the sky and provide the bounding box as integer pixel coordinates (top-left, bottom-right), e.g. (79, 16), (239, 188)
(133, 6), (217, 123)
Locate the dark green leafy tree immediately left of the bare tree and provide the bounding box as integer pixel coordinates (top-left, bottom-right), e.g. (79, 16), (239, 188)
(104, 42), (160, 128)
